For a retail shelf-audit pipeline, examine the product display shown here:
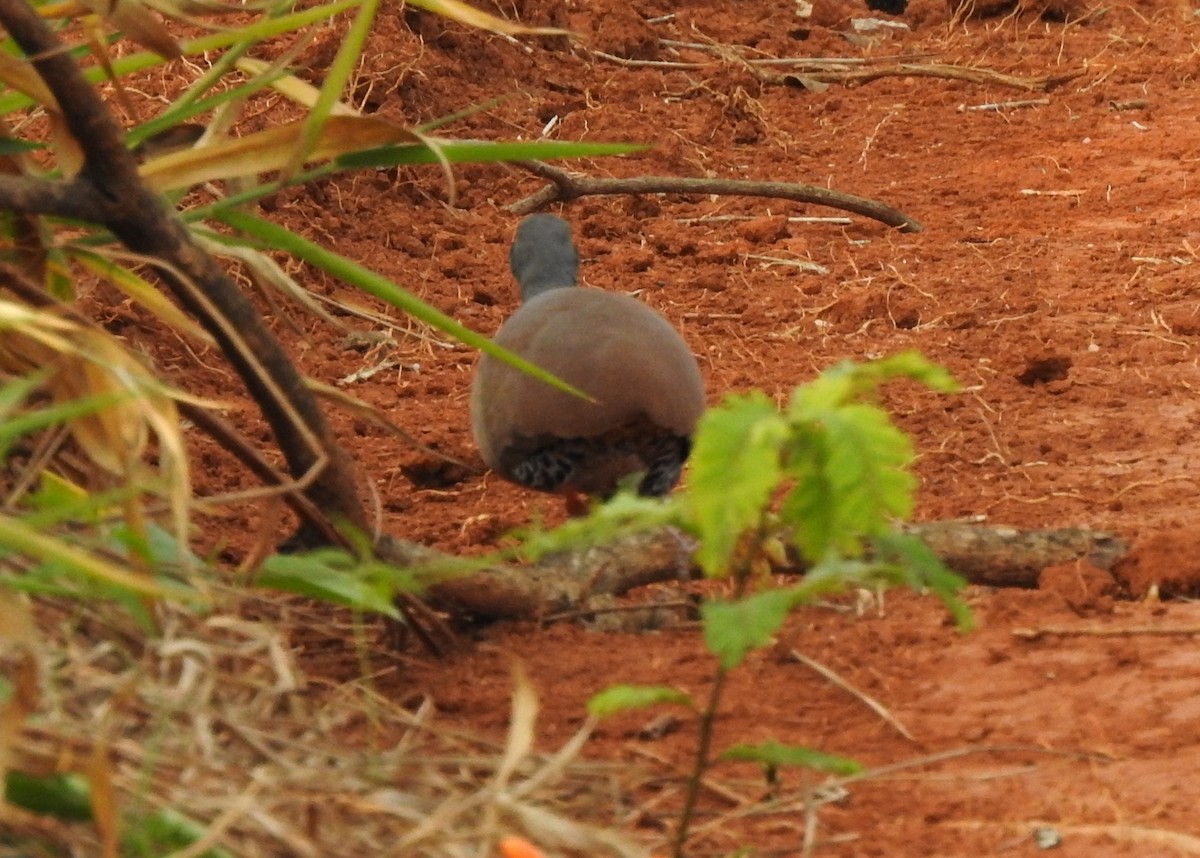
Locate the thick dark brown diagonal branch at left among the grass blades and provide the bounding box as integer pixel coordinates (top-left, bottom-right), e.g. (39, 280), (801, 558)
(0, 0), (366, 544)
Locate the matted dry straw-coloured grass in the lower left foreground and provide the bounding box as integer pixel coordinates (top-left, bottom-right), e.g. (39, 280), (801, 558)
(0, 593), (647, 858)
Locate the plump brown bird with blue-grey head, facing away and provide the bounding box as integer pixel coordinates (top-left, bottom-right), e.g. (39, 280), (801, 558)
(470, 214), (704, 512)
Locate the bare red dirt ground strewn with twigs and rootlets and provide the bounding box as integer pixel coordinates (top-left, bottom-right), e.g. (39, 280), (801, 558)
(126, 0), (1200, 858)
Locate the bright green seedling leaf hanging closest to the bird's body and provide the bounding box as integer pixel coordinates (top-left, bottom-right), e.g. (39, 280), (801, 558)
(688, 391), (787, 577)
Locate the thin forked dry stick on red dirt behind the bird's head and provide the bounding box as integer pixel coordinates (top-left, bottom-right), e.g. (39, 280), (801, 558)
(508, 161), (922, 233)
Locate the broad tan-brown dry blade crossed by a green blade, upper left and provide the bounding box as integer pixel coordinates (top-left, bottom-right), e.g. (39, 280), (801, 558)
(140, 116), (416, 191)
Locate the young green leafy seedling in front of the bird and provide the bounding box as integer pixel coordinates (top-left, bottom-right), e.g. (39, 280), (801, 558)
(566, 353), (971, 857)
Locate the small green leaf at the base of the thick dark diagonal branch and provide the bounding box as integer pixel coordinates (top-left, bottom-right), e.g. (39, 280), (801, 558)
(258, 551), (400, 619)
